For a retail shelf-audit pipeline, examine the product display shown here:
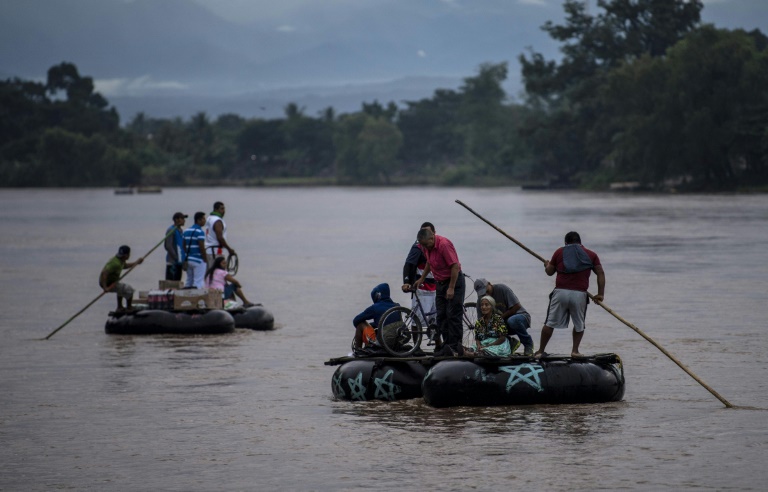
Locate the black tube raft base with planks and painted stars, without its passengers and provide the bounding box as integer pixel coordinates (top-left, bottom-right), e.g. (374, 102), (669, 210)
(325, 354), (624, 408)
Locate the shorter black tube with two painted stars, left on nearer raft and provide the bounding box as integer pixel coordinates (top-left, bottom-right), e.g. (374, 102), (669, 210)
(331, 358), (427, 401)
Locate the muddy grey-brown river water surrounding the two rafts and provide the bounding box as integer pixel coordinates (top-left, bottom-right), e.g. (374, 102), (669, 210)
(0, 188), (768, 491)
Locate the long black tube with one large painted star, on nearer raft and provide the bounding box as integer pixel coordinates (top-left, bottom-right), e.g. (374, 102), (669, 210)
(422, 354), (624, 408)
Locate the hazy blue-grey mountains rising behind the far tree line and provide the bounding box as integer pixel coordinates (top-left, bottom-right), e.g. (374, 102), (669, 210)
(0, 0), (768, 121)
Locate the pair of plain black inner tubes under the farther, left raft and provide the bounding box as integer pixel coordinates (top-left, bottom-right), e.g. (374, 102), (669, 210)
(104, 306), (275, 335)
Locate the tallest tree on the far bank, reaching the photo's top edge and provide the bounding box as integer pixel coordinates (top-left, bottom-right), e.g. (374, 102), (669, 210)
(519, 0), (702, 182)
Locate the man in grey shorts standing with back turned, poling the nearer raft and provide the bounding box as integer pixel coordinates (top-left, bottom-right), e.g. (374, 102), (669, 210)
(534, 231), (605, 357)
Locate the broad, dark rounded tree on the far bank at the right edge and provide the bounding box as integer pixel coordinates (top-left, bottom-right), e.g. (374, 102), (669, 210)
(601, 26), (768, 189)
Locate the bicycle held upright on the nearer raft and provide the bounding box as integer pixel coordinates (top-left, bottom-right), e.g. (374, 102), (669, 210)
(376, 284), (477, 357)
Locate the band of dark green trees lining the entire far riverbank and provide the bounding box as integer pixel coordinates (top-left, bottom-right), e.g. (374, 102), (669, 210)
(0, 0), (768, 190)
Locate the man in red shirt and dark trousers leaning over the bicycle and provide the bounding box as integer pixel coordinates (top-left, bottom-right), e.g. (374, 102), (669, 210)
(414, 228), (466, 356)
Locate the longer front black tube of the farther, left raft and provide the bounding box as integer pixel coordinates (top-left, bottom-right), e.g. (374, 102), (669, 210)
(104, 309), (235, 335)
